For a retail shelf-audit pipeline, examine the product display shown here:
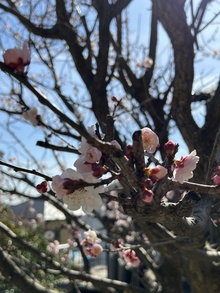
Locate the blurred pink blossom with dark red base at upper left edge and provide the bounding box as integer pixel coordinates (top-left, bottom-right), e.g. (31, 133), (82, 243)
(3, 41), (31, 74)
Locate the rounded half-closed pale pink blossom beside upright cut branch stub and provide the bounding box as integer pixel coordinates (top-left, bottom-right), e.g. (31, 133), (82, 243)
(141, 127), (159, 153)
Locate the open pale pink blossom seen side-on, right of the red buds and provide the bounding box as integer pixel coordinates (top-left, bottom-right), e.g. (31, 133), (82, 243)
(172, 150), (199, 183)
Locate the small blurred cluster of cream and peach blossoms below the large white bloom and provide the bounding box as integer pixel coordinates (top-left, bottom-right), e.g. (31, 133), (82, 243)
(81, 230), (103, 258)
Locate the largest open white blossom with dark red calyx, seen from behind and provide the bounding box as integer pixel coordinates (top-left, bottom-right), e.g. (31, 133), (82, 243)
(52, 168), (103, 213)
